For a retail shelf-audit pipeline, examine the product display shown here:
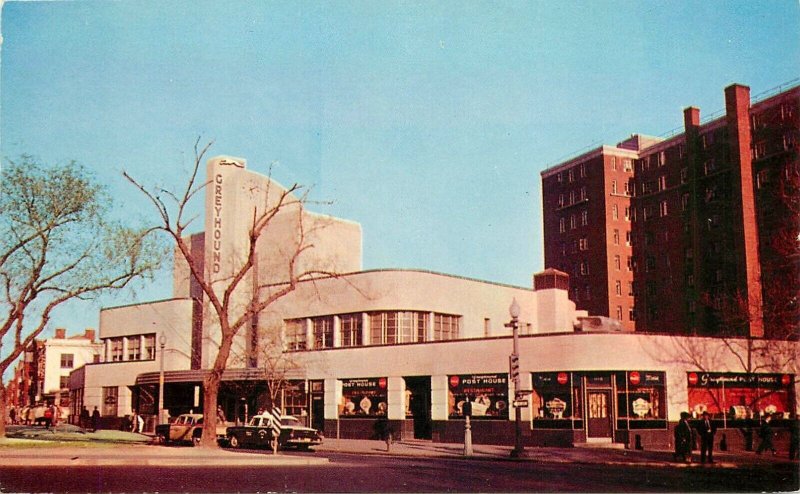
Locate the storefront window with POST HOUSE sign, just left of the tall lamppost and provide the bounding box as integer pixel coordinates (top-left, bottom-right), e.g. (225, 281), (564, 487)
(447, 374), (508, 419)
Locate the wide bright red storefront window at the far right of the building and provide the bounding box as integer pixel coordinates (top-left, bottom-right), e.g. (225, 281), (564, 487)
(687, 372), (795, 420)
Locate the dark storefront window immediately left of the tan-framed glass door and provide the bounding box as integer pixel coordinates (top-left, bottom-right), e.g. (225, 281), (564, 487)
(531, 372), (583, 429)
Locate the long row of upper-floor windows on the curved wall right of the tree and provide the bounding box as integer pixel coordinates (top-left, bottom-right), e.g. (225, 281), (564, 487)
(284, 311), (461, 350)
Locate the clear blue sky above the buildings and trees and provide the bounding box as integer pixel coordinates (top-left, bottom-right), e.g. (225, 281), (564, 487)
(0, 0), (800, 340)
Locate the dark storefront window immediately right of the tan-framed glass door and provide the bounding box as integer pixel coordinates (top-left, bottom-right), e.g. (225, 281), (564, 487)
(616, 371), (667, 429)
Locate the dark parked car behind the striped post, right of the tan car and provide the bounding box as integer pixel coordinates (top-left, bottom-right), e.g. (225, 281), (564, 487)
(226, 414), (323, 449)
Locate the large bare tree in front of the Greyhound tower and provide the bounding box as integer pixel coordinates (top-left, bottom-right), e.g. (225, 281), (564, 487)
(125, 139), (336, 448)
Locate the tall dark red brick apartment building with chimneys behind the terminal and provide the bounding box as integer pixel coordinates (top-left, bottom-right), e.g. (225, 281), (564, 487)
(542, 85), (800, 337)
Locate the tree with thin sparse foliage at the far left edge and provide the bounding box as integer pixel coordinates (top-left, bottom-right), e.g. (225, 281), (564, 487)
(0, 156), (164, 437)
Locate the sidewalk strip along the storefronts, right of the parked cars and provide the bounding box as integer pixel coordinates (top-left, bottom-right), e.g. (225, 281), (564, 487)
(316, 438), (798, 468)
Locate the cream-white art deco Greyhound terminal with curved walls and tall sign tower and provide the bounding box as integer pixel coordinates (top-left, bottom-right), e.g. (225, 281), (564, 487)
(70, 156), (797, 447)
